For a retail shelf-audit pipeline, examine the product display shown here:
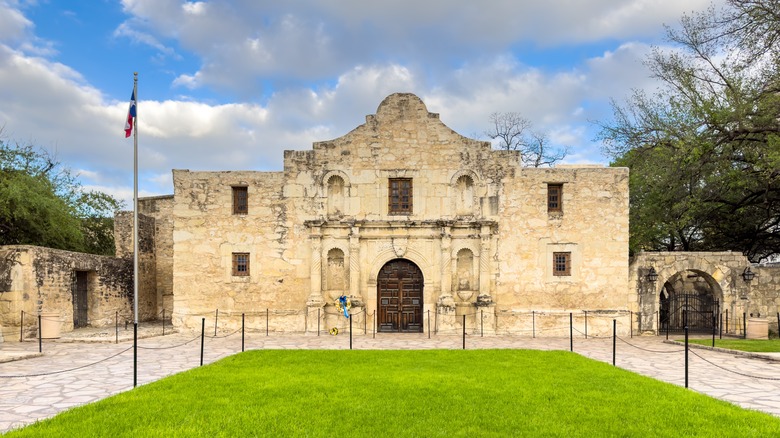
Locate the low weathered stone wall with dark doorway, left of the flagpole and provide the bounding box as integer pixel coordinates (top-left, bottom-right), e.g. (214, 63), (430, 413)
(0, 245), (132, 336)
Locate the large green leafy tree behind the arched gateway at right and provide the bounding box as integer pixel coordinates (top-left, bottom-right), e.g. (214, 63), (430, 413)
(600, 0), (780, 261)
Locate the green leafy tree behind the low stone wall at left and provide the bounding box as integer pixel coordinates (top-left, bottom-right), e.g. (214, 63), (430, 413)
(0, 133), (121, 255)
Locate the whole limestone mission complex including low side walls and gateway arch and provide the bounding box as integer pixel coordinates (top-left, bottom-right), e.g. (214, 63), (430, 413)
(0, 93), (780, 336)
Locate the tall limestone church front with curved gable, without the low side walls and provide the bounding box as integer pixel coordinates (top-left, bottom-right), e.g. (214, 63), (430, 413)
(168, 94), (635, 333)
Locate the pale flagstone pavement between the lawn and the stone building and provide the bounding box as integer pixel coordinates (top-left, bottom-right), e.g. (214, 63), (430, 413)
(0, 327), (780, 433)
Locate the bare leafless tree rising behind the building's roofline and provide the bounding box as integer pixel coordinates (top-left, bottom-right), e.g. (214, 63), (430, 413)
(485, 112), (568, 167)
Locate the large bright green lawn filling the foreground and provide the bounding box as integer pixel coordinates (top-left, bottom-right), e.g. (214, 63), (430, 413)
(7, 350), (780, 437)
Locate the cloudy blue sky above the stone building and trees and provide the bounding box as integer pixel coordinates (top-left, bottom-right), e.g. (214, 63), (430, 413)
(0, 0), (710, 206)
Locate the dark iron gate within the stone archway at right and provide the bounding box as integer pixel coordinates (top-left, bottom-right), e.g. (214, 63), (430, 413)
(659, 294), (719, 333)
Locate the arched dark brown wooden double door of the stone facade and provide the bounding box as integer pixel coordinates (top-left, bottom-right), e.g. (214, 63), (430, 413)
(376, 259), (423, 333)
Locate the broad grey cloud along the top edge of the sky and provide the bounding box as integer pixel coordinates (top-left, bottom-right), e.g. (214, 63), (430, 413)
(118, 0), (710, 95)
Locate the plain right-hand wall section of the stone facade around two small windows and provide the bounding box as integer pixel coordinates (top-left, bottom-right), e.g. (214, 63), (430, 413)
(497, 166), (630, 311)
